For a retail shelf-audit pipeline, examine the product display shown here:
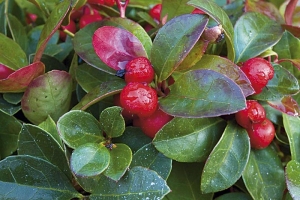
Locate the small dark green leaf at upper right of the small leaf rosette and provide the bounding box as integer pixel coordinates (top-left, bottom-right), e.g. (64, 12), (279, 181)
(100, 106), (125, 137)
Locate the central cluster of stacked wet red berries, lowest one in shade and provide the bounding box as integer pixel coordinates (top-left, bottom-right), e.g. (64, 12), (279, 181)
(114, 57), (173, 138)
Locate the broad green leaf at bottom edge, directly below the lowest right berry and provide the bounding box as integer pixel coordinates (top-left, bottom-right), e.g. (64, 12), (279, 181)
(242, 146), (285, 199)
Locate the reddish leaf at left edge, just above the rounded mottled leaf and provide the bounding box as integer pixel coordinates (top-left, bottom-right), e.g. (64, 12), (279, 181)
(0, 62), (45, 93)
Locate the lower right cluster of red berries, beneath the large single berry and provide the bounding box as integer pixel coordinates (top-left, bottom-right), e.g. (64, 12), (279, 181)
(235, 100), (275, 149)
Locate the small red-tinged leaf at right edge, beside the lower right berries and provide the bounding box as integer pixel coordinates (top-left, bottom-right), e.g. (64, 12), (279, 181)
(268, 96), (300, 116)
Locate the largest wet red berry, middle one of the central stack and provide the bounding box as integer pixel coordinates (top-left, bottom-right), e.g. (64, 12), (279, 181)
(120, 82), (158, 117)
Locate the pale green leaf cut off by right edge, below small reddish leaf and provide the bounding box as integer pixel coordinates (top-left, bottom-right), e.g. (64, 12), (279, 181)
(282, 114), (300, 162)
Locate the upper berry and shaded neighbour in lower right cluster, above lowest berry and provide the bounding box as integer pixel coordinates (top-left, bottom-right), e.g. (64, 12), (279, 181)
(235, 100), (266, 129)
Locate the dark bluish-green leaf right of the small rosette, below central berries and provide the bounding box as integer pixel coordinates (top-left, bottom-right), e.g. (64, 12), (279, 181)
(130, 143), (172, 180)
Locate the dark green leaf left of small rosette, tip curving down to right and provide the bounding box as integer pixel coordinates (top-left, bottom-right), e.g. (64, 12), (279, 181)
(18, 124), (72, 180)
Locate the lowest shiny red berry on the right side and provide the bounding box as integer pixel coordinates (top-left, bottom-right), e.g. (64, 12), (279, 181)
(247, 118), (275, 149)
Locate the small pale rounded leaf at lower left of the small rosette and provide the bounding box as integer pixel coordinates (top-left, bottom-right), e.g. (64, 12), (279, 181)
(70, 143), (110, 177)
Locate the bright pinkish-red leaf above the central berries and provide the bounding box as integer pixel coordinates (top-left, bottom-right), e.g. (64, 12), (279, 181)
(92, 26), (147, 70)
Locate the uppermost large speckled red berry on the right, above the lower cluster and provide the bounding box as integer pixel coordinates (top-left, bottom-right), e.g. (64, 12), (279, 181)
(241, 57), (274, 94)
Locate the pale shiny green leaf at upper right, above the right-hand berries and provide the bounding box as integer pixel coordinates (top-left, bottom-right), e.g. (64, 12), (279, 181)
(234, 12), (283, 63)
